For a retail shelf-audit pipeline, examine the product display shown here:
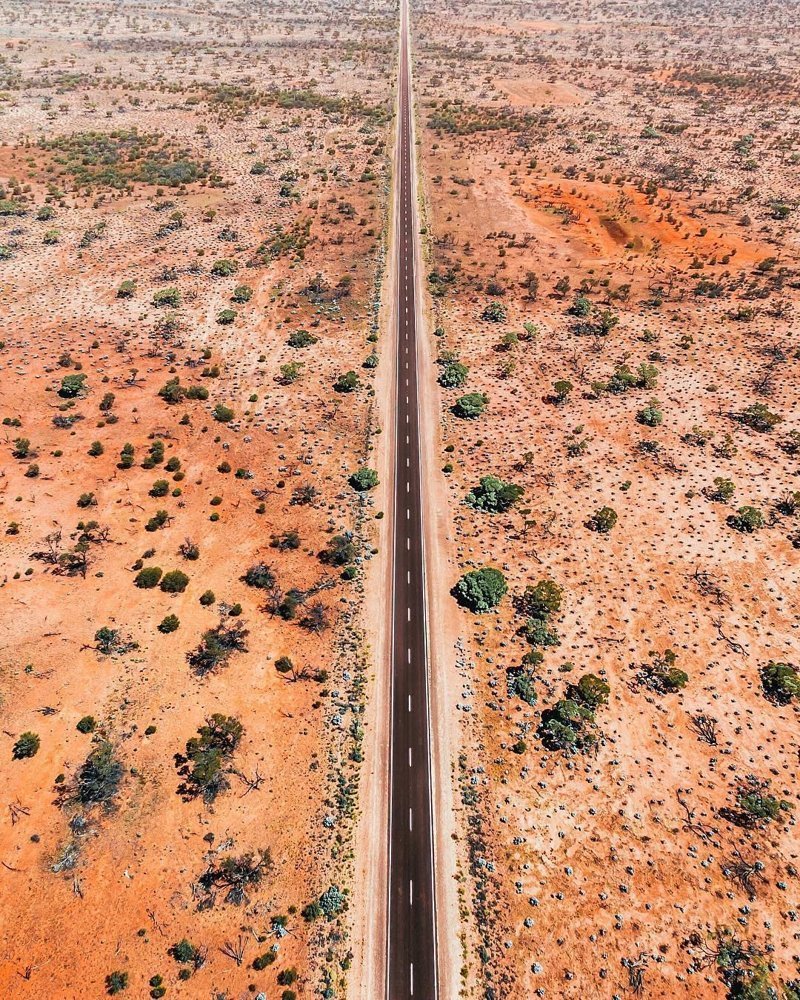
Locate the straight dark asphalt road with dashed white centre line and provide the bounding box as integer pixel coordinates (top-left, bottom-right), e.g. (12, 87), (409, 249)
(386, 0), (438, 1000)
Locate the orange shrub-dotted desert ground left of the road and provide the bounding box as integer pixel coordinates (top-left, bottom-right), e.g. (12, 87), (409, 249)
(0, 0), (396, 1000)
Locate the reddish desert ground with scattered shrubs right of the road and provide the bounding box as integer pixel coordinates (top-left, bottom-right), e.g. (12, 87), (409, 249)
(413, 0), (800, 1000)
